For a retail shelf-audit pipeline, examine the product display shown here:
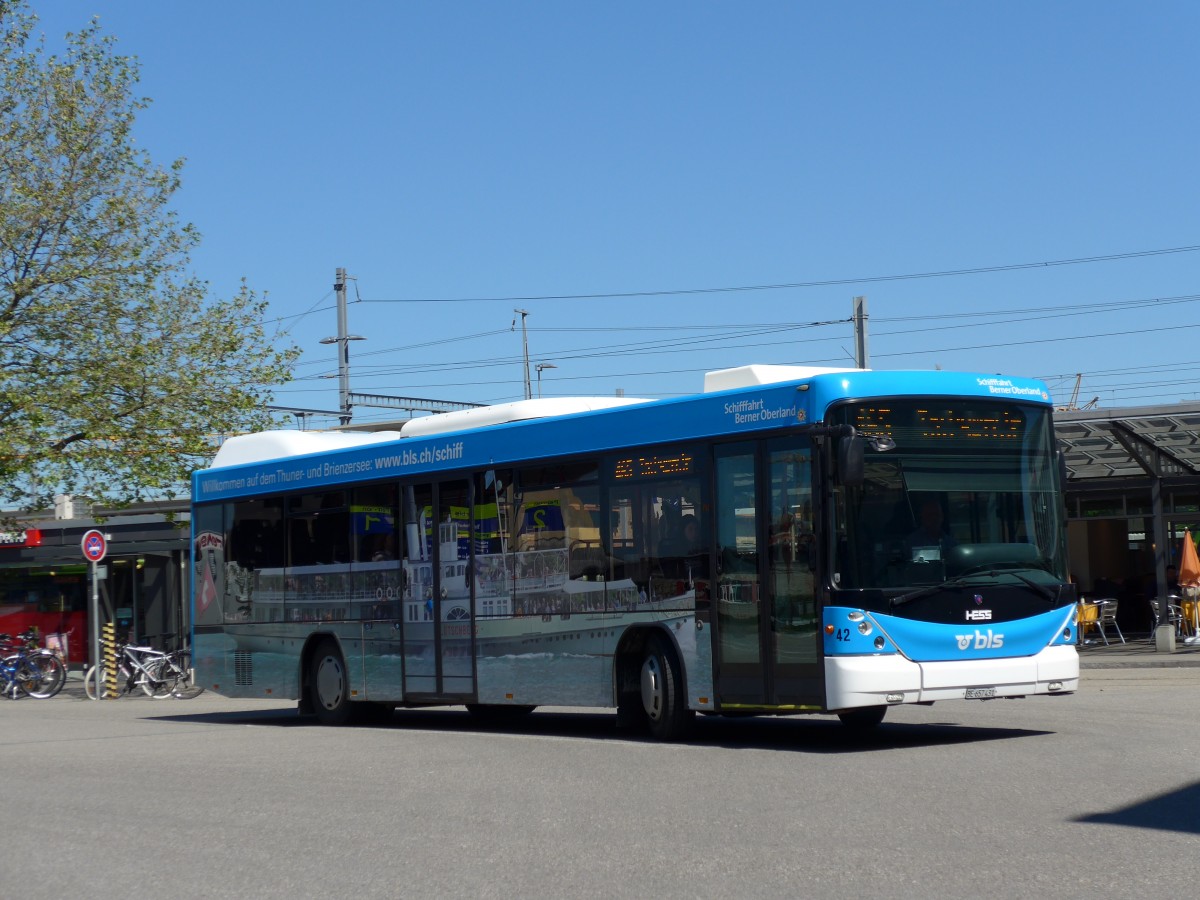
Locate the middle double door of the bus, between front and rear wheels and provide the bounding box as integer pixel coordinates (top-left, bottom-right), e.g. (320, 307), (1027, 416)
(402, 481), (475, 702)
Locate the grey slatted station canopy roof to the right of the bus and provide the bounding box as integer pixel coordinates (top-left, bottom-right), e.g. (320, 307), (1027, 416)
(1055, 403), (1200, 481)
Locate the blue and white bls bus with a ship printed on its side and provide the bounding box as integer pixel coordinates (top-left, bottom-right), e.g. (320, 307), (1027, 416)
(192, 366), (1079, 739)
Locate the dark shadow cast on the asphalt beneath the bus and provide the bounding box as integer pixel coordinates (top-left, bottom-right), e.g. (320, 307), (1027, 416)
(147, 708), (1052, 754)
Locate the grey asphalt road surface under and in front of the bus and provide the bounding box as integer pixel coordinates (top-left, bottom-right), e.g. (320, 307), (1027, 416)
(0, 668), (1200, 900)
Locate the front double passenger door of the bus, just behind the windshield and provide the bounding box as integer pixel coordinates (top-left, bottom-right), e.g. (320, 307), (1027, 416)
(715, 438), (823, 710)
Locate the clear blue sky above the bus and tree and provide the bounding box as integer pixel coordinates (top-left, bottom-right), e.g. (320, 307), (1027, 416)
(28, 0), (1200, 424)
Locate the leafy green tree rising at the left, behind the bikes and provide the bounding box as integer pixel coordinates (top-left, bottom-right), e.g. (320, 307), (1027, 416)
(0, 0), (296, 509)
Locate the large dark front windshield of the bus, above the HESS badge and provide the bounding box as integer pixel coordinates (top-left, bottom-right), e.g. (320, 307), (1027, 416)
(834, 400), (1066, 593)
